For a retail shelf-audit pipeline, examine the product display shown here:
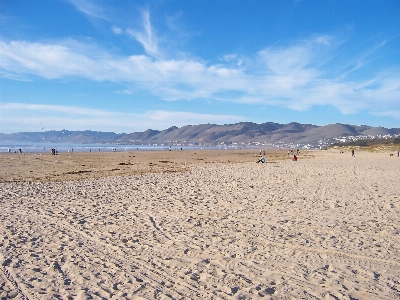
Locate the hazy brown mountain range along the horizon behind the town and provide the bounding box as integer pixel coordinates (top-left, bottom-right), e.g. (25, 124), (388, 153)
(0, 122), (400, 144)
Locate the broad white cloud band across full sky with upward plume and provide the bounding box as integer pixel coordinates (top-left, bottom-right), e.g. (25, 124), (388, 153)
(0, 28), (400, 120)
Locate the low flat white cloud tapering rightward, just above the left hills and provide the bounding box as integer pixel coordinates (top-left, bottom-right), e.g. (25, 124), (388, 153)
(0, 103), (243, 133)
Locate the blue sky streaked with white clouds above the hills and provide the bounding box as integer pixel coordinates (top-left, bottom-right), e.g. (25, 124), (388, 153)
(0, 0), (400, 133)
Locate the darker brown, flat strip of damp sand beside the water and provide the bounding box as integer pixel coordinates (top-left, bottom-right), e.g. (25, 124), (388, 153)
(0, 149), (298, 182)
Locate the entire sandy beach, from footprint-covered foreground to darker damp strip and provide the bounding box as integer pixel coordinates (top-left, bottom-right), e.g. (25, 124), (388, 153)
(0, 150), (400, 299)
